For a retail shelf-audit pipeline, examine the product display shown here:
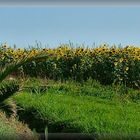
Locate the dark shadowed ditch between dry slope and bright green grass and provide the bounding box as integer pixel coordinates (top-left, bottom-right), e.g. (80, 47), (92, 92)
(17, 107), (95, 140)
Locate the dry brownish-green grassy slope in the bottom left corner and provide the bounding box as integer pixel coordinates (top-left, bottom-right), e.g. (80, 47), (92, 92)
(0, 112), (38, 140)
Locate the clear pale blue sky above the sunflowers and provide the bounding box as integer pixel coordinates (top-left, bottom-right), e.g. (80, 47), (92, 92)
(0, 6), (140, 48)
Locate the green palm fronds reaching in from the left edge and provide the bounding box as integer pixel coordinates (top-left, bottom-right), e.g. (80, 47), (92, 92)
(0, 45), (48, 115)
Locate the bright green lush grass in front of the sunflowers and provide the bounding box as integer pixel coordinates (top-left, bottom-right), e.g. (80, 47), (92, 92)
(14, 80), (140, 139)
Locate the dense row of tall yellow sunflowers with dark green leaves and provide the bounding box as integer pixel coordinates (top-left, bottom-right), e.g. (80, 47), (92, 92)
(0, 44), (140, 88)
